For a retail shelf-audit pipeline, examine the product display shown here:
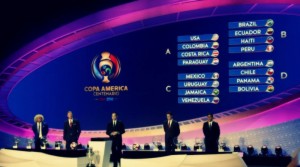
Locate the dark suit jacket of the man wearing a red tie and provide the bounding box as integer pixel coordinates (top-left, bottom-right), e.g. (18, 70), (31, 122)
(64, 119), (81, 141)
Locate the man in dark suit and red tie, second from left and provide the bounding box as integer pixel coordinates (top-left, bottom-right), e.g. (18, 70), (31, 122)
(64, 111), (81, 150)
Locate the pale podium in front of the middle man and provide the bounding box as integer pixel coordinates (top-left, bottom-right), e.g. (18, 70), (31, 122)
(89, 138), (112, 167)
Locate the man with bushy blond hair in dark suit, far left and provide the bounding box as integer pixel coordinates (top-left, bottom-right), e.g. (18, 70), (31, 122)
(32, 114), (49, 150)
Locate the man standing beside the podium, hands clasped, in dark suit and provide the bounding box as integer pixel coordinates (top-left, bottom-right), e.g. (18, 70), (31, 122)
(106, 112), (125, 167)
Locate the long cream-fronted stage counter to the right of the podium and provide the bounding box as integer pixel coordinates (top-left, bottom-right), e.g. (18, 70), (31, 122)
(121, 151), (247, 167)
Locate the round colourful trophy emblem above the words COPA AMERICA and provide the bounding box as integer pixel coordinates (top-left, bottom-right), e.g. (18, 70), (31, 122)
(91, 52), (121, 83)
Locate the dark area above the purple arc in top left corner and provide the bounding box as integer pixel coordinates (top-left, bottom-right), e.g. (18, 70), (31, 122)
(0, 0), (133, 65)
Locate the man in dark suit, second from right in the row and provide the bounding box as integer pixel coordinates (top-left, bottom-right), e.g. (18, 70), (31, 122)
(163, 112), (180, 153)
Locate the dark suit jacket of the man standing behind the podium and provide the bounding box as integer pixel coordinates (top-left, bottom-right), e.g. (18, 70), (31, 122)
(106, 120), (125, 145)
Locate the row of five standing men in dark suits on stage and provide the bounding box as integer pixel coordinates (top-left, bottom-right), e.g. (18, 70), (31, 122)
(32, 111), (220, 167)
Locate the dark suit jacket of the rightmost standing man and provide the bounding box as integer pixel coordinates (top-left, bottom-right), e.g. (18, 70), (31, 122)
(203, 121), (220, 140)
